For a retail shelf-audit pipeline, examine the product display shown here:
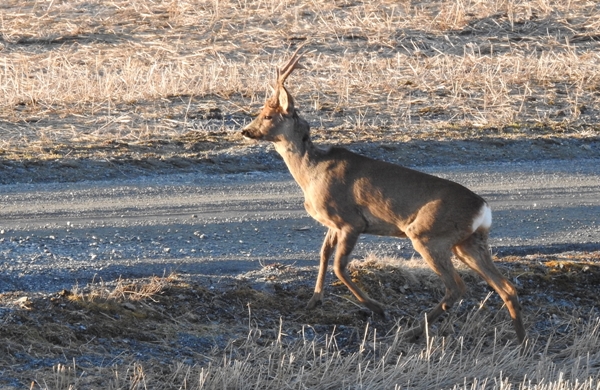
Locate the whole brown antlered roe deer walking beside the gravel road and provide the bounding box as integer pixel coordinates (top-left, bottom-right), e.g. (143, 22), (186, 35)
(242, 49), (525, 343)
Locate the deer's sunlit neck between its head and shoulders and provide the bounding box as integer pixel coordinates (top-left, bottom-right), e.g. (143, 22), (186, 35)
(274, 118), (319, 189)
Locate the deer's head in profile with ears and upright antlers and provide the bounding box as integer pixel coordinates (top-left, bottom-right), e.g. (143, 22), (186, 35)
(242, 46), (308, 142)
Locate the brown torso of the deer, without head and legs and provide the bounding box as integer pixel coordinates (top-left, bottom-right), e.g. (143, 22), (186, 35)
(278, 139), (486, 242)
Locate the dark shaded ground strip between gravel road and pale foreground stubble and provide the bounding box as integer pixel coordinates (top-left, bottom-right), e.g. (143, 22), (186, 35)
(0, 252), (600, 388)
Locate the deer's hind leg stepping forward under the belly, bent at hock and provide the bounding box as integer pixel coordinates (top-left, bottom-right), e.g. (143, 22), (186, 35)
(405, 238), (466, 339)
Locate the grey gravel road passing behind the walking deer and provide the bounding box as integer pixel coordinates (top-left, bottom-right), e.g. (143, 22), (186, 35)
(0, 159), (600, 293)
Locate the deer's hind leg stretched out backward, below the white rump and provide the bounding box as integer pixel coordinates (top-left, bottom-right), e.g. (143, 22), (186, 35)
(452, 230), (525, 343)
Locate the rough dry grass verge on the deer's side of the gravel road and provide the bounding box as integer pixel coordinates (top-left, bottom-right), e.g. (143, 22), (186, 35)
(0, 252), (600, 390)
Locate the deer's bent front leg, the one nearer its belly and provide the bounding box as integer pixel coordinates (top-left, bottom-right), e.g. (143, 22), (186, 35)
(333, 230), (385, 318)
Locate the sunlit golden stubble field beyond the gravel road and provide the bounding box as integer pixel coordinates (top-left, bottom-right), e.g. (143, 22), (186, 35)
(0, 0), (600, 158)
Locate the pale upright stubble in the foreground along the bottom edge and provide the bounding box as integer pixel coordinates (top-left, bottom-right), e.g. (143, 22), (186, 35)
(104, 318), (600, 390)
